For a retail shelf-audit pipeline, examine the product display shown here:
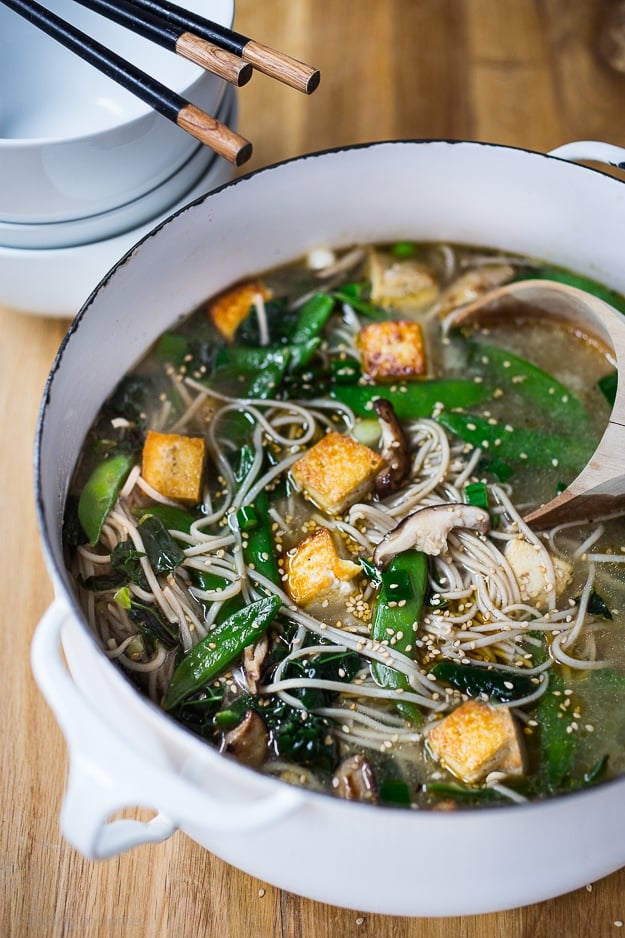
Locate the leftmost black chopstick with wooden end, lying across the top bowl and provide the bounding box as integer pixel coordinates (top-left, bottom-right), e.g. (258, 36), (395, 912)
(0, 0), (252, 166)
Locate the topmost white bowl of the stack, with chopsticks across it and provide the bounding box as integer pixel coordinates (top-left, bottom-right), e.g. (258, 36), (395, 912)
(0, 0), (234, 224)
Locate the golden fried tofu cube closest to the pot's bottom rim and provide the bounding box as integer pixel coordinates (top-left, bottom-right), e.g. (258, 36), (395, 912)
(428, 700), (524, 784)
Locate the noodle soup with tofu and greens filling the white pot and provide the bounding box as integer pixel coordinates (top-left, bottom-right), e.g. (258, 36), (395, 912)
(64, 242), (625, 809)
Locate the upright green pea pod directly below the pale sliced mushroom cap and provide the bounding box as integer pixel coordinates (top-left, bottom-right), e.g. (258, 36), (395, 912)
(371, 550), (428, 724)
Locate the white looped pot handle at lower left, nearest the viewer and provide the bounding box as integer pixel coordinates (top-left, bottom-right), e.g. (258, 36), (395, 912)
(31, 599), (302, 860)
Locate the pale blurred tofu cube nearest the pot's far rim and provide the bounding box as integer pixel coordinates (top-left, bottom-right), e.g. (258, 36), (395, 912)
(368, 251), (438, 311)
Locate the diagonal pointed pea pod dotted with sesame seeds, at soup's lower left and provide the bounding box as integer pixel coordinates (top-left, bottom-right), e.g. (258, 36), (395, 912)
(163, 596), (281, 710)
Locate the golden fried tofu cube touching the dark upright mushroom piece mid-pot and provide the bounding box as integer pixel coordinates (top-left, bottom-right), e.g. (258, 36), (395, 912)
(291, 430), (385, 515)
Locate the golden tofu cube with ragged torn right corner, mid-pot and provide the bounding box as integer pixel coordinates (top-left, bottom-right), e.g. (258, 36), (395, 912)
(285, 527), (362, 606)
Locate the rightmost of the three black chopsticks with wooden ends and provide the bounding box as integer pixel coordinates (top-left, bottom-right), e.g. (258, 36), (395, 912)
(111, 0), (320, 94)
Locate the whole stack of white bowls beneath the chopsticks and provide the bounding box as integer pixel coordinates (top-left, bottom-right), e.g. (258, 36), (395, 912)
(0, 0), (237, 317)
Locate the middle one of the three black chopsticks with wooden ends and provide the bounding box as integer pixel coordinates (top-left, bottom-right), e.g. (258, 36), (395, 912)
(71, 0), (252, 87)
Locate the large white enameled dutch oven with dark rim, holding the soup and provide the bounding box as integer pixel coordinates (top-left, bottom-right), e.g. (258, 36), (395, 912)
(32, 141), (625, 916)
